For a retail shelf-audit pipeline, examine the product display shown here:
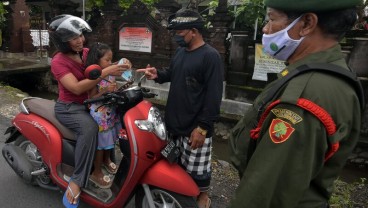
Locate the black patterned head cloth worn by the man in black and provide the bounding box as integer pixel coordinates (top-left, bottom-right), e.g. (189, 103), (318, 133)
(167, 9), (204, 30)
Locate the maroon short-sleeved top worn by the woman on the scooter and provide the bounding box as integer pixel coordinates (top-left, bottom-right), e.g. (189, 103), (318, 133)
(51, 48), (89, 104)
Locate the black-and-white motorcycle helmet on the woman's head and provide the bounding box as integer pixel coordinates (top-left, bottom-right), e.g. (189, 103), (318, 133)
(48, 14), (92, 53)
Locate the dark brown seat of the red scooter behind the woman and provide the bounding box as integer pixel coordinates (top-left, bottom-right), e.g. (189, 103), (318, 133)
(24, 98), (75, 140)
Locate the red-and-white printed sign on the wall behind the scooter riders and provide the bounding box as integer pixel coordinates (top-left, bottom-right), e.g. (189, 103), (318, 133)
(119, 27), (152, 53)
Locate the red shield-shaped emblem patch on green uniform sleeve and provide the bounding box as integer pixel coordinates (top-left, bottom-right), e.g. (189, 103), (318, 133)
(269, 118), (295, 143)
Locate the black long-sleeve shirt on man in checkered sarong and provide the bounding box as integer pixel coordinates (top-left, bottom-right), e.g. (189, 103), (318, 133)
(155, 44), (224, 137)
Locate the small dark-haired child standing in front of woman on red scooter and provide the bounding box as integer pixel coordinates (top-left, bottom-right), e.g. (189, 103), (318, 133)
(86, 42), (131, 188)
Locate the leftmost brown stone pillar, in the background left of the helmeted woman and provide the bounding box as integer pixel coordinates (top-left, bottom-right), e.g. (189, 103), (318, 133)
(9, 0), (34, 53)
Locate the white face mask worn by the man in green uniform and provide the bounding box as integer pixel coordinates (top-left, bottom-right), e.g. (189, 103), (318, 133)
(262, 17), (304, 61)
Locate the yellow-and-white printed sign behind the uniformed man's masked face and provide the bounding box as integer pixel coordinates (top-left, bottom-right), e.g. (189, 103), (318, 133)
(252, 44), (285, 81)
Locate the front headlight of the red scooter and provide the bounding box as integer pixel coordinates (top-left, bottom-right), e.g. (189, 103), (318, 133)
(135, 107), (167, 141)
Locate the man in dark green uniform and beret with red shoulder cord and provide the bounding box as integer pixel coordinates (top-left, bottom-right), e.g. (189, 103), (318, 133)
(230, 0), (364, 208)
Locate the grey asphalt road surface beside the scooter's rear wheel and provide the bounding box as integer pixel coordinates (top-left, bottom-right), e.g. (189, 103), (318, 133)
(0, 115), (134, 208)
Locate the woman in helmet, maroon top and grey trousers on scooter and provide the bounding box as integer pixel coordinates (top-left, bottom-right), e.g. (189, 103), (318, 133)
(49, 15), (128, 207)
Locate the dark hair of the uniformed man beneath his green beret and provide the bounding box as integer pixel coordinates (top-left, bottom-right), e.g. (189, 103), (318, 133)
(285, 8), (357, 41)
